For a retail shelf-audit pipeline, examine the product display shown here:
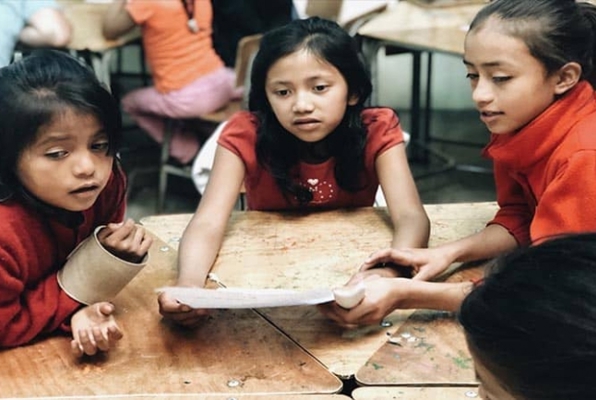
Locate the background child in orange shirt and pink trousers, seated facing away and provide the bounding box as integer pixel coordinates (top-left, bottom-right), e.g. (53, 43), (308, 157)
(103, 0), (242, 164)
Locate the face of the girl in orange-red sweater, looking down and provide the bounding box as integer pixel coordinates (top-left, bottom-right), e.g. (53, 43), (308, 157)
(464, 18), (559, 134)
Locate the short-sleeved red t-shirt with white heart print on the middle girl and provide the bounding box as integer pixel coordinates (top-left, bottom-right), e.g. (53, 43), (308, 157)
(218, 108), (404, 211)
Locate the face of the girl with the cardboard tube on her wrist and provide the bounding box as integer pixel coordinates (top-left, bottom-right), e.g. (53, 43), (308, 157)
(17, 110), (114, 211)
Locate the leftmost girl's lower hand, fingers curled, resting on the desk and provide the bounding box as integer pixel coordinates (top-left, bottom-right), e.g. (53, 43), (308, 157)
(70, 302), (122, 357)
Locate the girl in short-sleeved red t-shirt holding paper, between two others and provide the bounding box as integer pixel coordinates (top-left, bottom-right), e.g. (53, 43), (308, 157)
(159, 17), (429, 325)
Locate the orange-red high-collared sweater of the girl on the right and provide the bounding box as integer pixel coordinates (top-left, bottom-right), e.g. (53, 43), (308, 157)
(483, 81), (596, 245)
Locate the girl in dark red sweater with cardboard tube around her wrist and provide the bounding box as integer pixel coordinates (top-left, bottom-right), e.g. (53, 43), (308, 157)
(0, 51), (151, 356)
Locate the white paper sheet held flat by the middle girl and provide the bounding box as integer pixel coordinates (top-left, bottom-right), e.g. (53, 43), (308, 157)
(157, 286), (334, 308)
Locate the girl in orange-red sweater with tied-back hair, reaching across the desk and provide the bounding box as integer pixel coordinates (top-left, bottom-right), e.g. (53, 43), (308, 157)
(327, 0), (596, 324)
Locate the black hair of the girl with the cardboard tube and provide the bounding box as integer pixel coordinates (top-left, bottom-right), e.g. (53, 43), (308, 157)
(0, 50), (124, 201)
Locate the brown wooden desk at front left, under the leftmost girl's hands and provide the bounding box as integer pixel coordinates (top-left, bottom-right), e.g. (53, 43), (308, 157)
(0, 240), (342, 400)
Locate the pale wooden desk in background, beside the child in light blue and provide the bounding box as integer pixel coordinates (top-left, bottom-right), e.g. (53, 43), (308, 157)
(58, 0), (141, 52)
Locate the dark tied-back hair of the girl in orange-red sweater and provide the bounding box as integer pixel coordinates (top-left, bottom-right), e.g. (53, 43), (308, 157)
(470, 0), (596, 86)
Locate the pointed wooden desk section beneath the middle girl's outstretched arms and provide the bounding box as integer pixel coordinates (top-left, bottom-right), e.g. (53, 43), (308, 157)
(141, 203), (497, 378)
